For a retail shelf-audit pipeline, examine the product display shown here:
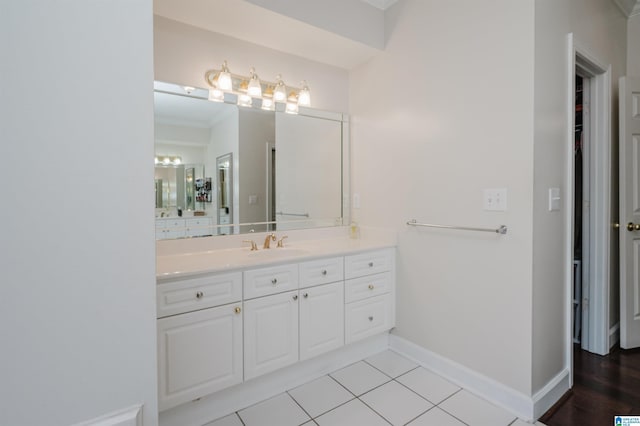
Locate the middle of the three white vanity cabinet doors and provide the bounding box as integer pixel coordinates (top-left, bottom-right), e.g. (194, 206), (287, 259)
(244, 291), (298, 380)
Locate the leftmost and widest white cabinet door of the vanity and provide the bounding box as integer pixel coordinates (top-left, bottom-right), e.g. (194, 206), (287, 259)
(158, 304), (242, 411)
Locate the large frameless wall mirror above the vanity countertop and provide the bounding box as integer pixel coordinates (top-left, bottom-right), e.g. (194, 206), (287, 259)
(154, 82), (349, 239)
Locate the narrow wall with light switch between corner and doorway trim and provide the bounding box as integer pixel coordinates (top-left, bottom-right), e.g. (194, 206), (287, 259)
(532, 0), (572, 393)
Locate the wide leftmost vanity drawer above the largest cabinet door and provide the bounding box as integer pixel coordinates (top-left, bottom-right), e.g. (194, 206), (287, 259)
(156, 272), (242, 318)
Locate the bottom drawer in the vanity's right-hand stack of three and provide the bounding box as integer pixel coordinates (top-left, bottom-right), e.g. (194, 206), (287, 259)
(344, 294), (393, 343)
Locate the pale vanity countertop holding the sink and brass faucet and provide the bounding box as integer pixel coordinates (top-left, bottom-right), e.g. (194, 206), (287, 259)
(156, 226), (396, 283)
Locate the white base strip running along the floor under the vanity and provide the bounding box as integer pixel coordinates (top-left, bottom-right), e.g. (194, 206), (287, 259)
(159, 333), (389, 426)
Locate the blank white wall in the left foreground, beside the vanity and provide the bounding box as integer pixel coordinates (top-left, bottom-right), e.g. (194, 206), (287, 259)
(0, 0), (157, 426)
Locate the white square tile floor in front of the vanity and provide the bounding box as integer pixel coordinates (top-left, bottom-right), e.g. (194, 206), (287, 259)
(205, 350), (544, 426)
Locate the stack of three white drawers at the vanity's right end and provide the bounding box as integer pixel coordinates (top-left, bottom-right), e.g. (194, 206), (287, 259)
(344, 249), (395, 343)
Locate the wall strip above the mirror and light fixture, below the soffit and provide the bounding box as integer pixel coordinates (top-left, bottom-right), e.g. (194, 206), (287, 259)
(154, 16), (349, 112)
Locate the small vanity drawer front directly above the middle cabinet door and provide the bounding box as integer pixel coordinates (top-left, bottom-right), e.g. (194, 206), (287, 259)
(244, 264), (298, 299)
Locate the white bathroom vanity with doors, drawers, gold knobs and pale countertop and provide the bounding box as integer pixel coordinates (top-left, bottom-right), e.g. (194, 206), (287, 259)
(157, 230), (395, 418)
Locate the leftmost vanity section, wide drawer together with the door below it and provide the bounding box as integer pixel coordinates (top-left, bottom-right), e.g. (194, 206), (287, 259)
(156, 272), (243, 411)
